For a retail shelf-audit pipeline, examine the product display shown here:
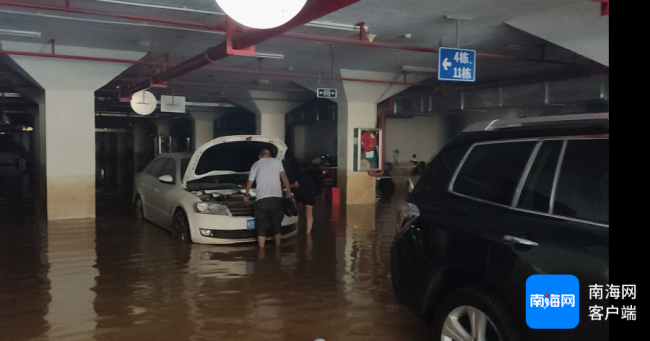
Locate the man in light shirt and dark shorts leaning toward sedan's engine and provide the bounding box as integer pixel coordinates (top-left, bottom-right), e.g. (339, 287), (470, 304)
(244, 149), (292, 247)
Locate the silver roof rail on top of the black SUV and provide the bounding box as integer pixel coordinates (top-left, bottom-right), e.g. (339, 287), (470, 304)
(463, 113), (609, 132)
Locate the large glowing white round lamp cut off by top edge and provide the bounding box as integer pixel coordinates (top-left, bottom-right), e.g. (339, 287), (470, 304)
(216, 0), (307, 29)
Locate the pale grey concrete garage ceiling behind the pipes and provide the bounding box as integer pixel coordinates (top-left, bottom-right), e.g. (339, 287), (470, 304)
(0, 0), (604, 106)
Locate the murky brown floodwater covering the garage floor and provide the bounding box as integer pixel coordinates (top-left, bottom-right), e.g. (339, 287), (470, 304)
(0, 187), (430, 341)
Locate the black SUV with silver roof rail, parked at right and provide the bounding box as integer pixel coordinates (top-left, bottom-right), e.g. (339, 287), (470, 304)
(391, 114), (609, 341)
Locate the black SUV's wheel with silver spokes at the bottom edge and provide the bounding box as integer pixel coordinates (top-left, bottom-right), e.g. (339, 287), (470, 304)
(433, 287), (521, 341)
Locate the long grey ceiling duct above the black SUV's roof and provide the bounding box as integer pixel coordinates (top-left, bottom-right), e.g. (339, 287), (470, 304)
(395, 76), (609, 115)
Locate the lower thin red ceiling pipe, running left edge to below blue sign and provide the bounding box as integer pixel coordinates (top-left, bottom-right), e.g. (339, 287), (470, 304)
(0, 48), (426, 86)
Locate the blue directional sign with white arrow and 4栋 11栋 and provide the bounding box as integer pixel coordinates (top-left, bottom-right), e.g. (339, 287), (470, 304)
(438, 47), (476, 82)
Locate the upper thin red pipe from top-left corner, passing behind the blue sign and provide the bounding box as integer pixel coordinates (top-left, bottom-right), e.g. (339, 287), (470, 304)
(0, 0), (568, 64)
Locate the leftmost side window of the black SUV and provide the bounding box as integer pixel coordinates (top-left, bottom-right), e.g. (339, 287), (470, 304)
(452, 141), (536, 206)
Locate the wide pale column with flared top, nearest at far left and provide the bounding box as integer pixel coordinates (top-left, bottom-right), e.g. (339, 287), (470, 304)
(1, 41), (144, 220)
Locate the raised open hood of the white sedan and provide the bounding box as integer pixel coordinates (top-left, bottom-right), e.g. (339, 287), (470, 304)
(183, 135), (287, 188)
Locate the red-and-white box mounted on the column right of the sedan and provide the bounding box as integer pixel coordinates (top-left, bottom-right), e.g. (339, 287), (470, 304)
(353, 128), (384, 172)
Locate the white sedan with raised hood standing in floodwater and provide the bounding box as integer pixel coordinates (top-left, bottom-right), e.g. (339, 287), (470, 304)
(133, 135), (298, 244)
